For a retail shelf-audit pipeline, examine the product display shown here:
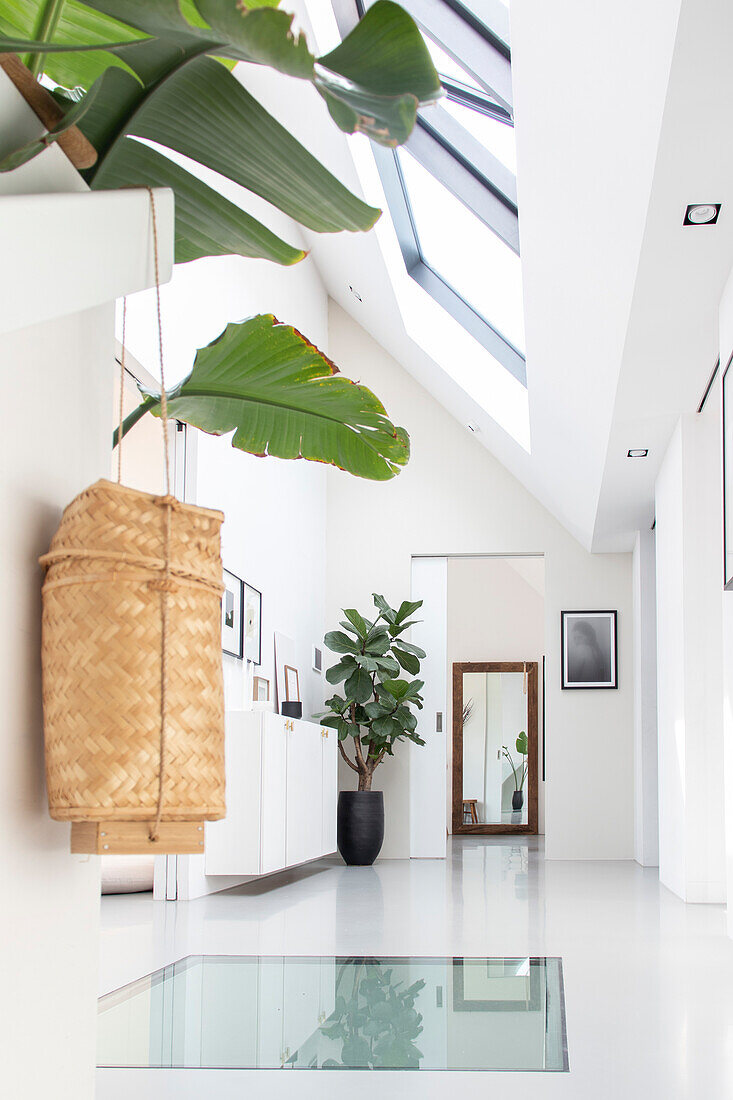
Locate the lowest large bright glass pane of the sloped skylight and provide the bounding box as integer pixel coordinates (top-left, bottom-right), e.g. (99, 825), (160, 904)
(398, 150), (524, 354)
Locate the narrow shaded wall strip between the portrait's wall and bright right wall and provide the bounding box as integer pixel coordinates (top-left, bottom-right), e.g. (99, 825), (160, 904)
(632, 530), (659, 867)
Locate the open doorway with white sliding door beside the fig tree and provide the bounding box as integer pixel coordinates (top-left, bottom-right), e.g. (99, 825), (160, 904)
(409, 553), (545, 858)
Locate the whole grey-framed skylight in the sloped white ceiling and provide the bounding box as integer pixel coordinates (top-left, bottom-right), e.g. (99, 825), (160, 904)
(335, 0), (526, 385)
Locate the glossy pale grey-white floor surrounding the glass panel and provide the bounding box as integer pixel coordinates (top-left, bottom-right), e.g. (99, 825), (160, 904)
(97, 837), (733, 1100)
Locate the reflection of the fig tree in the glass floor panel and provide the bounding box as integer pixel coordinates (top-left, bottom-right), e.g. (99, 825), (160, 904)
(320, 959), (425, 1069)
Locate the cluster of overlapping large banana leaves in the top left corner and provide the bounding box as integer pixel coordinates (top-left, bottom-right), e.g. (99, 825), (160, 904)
(0, 0), (440, 263)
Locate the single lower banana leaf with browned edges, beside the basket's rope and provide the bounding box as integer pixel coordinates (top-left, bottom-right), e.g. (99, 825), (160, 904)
(113, 314), (409, 481)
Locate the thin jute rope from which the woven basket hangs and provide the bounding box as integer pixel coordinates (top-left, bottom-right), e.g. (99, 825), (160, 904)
(117, 187), (173, 842)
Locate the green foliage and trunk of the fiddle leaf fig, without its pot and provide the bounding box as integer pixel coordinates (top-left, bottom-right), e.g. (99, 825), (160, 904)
(317, 593), (425, 791)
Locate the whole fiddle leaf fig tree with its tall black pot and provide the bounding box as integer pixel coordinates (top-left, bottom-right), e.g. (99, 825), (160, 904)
(317, 593), (425, 866)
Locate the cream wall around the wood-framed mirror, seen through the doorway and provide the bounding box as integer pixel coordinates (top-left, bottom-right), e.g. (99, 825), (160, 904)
(440, 558), (545, 833)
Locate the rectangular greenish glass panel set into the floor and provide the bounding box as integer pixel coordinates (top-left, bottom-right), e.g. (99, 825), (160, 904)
(98, 955), (568, 1071)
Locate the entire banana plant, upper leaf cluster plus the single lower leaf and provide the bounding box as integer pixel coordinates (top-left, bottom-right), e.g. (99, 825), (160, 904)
(0, 0), (441, 480)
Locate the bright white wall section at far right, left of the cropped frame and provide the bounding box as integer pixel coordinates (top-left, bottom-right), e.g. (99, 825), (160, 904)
(655, 400), (725, 902)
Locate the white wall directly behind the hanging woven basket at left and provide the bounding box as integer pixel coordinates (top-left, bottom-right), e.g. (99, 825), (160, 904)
(0, 306), (113, 1100)
